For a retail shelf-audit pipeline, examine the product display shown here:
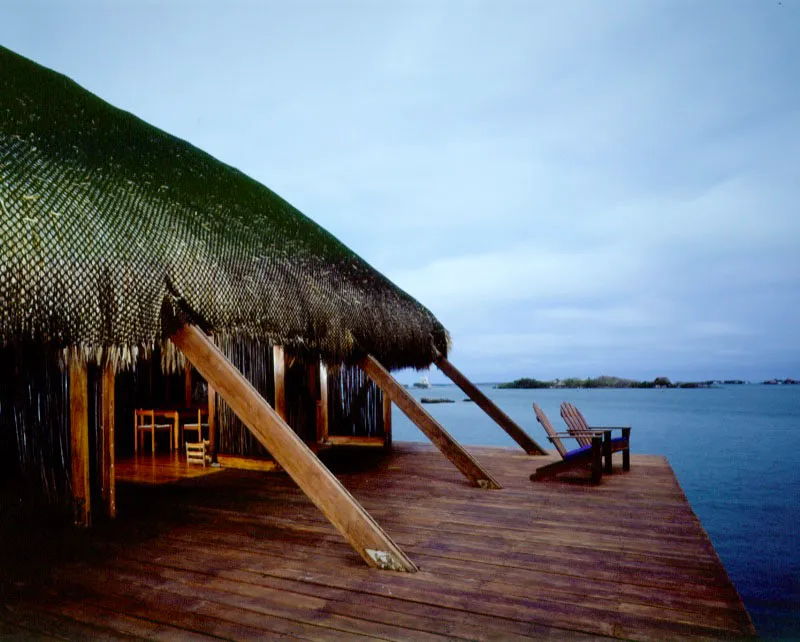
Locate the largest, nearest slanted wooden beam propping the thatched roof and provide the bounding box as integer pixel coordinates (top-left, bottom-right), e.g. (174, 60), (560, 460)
(171, 325), (417, 572)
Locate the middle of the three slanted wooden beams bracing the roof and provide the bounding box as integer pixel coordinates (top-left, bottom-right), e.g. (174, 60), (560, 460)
(360, 355), (502, 488)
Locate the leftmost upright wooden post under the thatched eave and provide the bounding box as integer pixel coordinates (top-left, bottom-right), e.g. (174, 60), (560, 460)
(69, 350), (92, 528)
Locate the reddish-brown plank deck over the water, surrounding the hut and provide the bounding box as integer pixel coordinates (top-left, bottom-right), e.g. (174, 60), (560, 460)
(0, 444), (754, 640)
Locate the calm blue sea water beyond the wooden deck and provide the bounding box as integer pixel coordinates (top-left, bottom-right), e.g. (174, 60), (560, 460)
(392, 385), (800, 639)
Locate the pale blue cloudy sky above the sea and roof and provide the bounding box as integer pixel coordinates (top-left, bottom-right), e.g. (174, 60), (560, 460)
(0, 0), (800, 383)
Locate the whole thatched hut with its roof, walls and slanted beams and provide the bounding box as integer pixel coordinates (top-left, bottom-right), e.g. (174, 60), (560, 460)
(0, 48), (541, 571)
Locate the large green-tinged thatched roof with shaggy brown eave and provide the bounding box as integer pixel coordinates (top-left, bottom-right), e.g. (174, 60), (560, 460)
(0, 47), (447, 368)
